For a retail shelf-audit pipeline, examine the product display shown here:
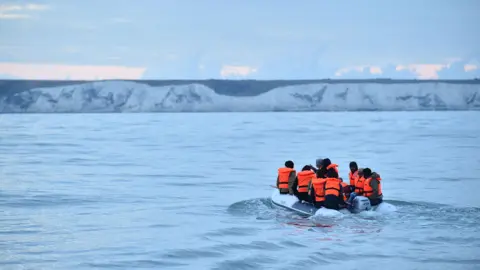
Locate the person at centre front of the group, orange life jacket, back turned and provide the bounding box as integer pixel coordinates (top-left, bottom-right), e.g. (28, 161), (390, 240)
(323, 164), (345, 210)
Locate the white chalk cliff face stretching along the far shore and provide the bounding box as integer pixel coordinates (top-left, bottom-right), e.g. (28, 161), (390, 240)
(0, 81), (480, 113)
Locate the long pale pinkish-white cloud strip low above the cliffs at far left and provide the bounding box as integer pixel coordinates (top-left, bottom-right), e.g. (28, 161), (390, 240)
(0, 63), (146, 80)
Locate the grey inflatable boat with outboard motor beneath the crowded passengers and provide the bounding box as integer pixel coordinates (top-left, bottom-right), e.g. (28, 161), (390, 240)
(271, 190), (381, 216)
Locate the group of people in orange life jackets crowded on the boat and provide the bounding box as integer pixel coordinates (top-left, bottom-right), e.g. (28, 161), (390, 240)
(277, 158), (383, 210)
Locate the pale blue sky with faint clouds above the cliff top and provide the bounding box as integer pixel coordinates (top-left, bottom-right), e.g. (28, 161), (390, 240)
(0, 0), (480, 80)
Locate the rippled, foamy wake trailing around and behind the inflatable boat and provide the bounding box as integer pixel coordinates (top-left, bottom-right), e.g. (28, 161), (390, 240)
(227, 195), (480, 232)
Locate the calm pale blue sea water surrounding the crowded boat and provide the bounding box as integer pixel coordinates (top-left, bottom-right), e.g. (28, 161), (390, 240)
(0, 112), (480, 270)
